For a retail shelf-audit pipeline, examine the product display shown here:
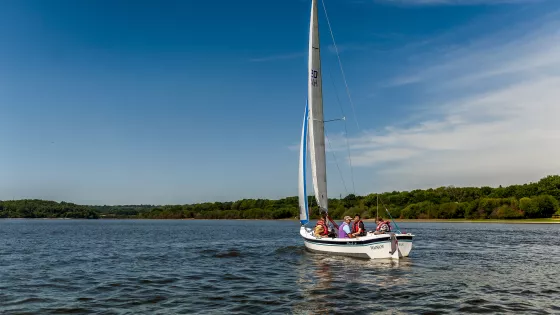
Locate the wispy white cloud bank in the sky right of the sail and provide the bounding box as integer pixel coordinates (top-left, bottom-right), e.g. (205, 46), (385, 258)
(331, 10), (560, 190)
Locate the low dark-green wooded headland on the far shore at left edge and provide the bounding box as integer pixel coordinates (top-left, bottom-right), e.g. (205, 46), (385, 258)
(0, 199), (99, 219)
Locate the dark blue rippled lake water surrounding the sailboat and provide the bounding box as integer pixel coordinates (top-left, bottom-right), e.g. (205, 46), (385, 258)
(0, 220), (560, 314)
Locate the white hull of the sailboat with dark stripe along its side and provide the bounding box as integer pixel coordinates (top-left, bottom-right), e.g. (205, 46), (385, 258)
(300, 226), (414, 259)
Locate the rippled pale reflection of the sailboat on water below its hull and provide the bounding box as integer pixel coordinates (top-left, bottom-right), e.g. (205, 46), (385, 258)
(292, 251), (412, 314)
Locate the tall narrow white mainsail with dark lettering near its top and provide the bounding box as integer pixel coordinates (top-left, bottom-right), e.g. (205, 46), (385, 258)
(308, 0), (328, 215)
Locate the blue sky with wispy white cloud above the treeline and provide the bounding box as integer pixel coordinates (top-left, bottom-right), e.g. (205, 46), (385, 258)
(0, 0), (560, 205)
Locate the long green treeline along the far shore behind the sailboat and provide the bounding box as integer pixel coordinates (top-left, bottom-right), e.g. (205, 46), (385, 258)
(0, 175), (560, 220)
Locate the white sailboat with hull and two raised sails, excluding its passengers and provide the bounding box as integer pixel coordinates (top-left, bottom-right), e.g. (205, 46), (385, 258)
(298, 0), (414, 259)
